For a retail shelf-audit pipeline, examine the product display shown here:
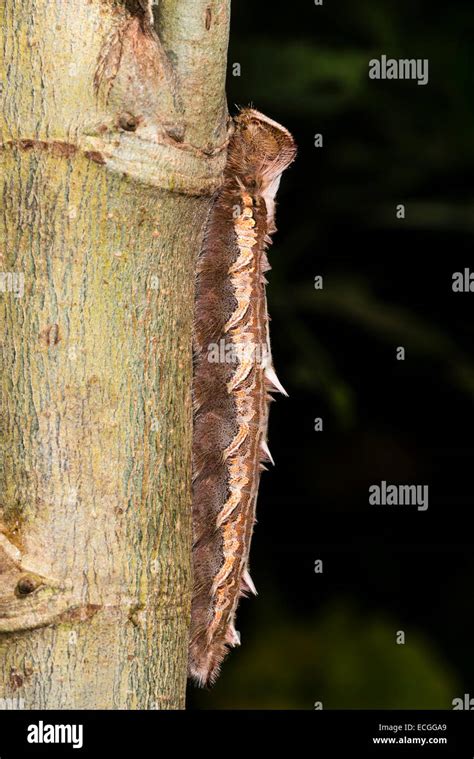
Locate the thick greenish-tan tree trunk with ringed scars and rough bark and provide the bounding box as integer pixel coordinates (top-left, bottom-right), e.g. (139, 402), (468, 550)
(0, 0), (230, 709)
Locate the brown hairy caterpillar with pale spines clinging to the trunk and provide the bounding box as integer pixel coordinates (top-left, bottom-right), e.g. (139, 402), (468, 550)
(189, 108), (296, 685)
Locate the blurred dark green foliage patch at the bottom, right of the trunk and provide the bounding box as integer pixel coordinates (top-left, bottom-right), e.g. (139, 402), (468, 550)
(194, 602), (460, 709)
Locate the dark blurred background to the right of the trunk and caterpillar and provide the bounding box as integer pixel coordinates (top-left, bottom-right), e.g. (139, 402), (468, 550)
(188, 0), (474, 709)
